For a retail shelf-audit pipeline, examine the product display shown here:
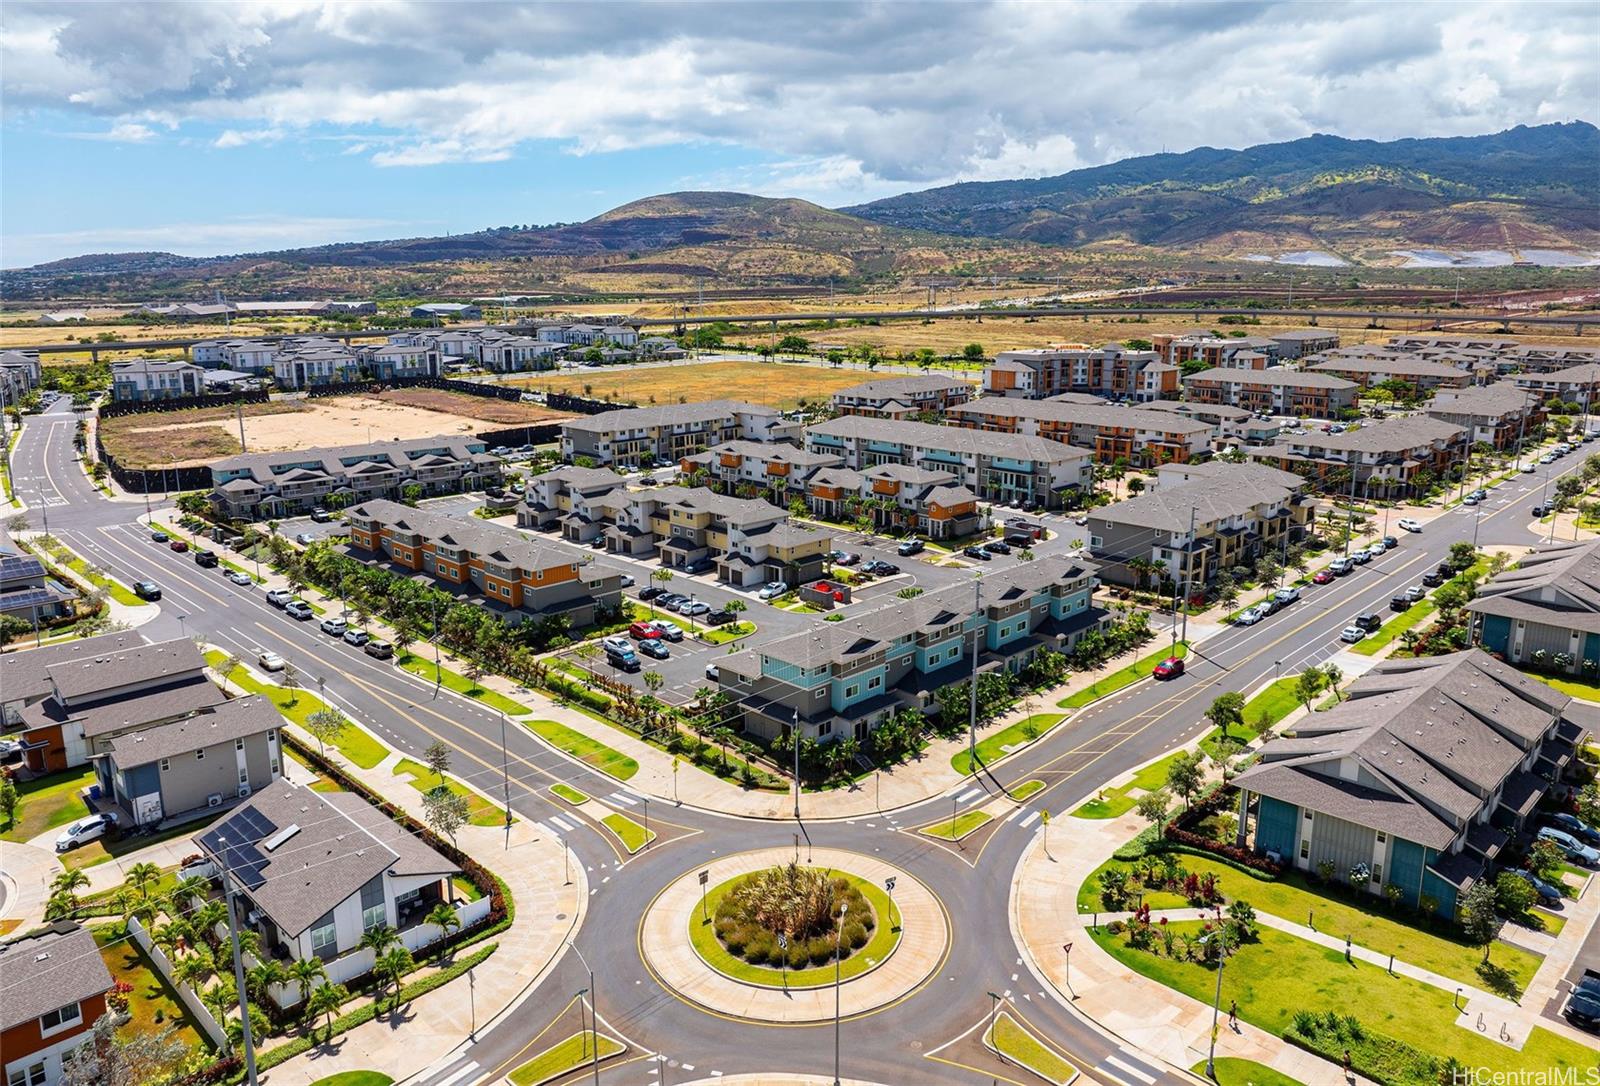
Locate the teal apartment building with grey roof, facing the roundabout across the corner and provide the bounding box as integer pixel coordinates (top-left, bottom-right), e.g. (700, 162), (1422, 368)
(717, 555), (1110, 742)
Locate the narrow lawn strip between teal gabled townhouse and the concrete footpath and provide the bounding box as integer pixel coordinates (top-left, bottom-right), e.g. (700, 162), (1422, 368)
(1078, 854), (1541, 992)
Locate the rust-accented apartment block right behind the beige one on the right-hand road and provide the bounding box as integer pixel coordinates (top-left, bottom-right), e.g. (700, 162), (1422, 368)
(1243, 416), (1467, 497)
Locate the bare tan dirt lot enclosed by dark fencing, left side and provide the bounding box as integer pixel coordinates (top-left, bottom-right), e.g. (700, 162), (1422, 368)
(101, 389), (565, 467)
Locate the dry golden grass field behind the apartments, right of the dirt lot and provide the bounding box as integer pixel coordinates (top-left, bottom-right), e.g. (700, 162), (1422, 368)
(518, 361), (934, 408)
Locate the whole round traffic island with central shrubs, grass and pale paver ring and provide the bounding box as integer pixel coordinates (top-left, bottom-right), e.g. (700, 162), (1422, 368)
(638, 849), (950, 1022)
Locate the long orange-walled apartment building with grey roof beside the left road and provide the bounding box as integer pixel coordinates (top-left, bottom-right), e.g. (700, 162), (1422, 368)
(346, 499), (622, 629)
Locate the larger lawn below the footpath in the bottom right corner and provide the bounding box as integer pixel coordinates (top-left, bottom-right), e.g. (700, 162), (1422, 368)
(1090, 921), (1595, 1072)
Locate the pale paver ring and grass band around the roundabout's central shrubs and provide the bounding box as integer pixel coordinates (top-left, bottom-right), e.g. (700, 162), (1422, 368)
(638, 848), (950, 1025)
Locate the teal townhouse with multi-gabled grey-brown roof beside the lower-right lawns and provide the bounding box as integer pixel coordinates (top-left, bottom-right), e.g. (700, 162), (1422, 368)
(1234, 649), (1586, 918)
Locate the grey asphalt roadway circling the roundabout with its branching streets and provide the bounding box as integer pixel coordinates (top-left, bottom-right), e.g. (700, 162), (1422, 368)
(16, 401), (1582, 1086)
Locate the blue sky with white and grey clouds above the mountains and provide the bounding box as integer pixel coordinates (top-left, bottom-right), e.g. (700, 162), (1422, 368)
(0, 0), (1600, 267)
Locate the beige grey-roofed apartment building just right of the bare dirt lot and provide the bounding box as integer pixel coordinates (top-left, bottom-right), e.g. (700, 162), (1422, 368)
(562, 400), (797, 464)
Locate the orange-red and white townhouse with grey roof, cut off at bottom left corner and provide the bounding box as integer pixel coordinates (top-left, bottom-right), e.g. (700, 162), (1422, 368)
(0, 921), (114, 1086)
